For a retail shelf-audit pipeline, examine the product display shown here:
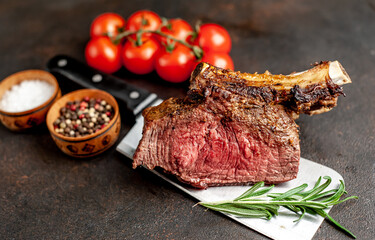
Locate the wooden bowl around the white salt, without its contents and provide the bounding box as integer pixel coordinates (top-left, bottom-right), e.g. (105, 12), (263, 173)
(0, 70), (61, 131)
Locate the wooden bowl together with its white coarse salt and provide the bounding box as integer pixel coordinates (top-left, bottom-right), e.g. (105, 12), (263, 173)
(0, 70), (61, 131)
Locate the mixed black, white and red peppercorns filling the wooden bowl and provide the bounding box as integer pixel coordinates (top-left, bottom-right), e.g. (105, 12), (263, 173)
(53, 97), (114, 137)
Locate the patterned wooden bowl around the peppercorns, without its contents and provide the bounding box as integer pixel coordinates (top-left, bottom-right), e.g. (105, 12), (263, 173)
(46, 89), (121, 158)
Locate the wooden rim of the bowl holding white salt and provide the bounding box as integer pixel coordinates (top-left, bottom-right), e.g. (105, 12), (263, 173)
(0, 69), (61, 117)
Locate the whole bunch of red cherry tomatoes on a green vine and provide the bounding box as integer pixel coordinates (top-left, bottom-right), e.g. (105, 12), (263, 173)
(85, 10), (234, 83)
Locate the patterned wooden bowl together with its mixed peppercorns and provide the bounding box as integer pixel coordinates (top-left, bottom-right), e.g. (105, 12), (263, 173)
(46, 89), (121, 158)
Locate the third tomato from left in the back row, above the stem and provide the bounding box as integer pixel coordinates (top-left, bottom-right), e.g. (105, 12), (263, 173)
(160, 18), (193, 44)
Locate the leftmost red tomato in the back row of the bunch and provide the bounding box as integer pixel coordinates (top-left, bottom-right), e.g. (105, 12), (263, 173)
(90, 13), (125, 38)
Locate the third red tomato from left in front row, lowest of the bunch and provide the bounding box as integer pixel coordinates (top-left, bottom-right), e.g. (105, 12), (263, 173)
(155, 44), (195, 83)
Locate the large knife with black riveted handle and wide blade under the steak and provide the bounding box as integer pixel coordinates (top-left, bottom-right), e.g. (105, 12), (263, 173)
(48, 55), (343, 240)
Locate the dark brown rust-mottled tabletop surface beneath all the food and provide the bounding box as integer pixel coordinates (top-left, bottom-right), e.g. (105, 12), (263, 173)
(0, 0), (375, 239)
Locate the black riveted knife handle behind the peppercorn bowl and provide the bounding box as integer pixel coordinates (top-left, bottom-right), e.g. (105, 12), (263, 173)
(47, 55), (156, 115)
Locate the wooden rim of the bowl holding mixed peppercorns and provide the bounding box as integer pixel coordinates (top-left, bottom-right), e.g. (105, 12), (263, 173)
(46, 88), (120, 142)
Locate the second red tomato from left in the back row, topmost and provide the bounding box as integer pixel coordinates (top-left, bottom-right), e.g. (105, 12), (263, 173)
(125, 10), (162, 31)
